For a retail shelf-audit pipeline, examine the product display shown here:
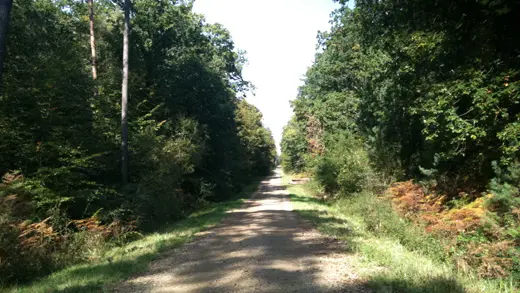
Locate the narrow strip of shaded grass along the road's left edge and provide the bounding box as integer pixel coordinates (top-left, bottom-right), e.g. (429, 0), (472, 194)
(0, 181), (259, 293)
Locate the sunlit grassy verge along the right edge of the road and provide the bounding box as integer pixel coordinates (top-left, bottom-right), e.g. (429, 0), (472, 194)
(284, 175), (518, 293)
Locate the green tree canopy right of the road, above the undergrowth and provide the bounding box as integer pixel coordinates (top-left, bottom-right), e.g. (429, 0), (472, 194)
(284, 0), (520, 182)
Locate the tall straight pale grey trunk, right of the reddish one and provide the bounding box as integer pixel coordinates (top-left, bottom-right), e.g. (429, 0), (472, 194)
(121, 0), (130, 184)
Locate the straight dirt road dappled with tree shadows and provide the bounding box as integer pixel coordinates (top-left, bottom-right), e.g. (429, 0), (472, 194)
(116, 170), (366, 293)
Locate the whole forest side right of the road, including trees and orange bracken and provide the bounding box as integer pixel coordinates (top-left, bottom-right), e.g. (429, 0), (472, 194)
(281, 0), (520, 292)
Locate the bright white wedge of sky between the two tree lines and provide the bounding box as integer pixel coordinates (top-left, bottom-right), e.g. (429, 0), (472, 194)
(194, 0), (339, 151)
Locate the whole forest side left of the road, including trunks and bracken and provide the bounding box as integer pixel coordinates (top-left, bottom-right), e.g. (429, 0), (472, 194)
(0, 0), (276, 282)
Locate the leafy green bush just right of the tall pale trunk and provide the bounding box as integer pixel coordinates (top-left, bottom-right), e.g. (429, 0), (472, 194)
(131, 118), (205, 227)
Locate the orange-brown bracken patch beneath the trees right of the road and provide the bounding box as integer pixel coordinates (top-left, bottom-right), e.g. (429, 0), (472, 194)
(389, 181), (520, 278)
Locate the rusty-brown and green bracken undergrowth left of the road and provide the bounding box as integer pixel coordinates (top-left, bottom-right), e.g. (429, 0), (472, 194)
(0, 172), (135, 284)
